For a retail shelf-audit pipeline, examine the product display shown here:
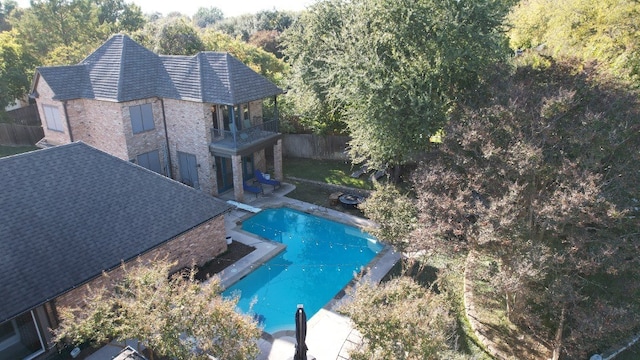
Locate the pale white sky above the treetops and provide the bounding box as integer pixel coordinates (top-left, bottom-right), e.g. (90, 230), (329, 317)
(18, 0), (315, 17)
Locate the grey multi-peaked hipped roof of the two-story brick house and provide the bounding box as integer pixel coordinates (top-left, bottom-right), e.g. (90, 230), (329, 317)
(33, 34), (283, 105)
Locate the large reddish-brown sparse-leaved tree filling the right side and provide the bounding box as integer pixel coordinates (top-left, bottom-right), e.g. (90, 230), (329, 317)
(410, 55), (640, 359)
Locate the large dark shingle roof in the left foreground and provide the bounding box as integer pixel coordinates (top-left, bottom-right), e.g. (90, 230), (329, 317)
(0, 142), (231, 323)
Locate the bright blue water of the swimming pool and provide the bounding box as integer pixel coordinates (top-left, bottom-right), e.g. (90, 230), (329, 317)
(223, 208), (382, 333)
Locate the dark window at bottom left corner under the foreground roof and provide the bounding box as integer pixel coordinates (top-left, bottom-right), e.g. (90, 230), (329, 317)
(0, 311), (44, 359)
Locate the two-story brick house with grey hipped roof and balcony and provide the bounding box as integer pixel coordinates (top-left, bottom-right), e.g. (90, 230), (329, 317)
(31, 34), (282, 201)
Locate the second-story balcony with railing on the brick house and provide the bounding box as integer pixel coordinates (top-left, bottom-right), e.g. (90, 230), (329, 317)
(209, 119), (282, 156)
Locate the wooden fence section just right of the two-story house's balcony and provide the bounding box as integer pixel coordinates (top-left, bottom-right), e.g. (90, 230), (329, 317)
(282, 134), (349, 160)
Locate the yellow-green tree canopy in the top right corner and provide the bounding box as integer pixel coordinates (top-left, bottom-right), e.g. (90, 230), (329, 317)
(509, 0), (640, 83)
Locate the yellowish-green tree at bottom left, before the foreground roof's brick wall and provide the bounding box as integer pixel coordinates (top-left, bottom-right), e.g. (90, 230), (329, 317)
(55, 261), (260, 360)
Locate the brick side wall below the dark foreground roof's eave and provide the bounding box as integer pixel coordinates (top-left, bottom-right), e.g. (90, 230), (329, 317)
(54, 215), (227, 308)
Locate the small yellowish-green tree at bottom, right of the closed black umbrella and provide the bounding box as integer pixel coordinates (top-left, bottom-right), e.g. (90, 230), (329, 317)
(339, 277), (456, 360)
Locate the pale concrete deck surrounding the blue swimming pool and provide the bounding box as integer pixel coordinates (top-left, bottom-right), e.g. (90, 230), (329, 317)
(220, 183), (400, 360)
